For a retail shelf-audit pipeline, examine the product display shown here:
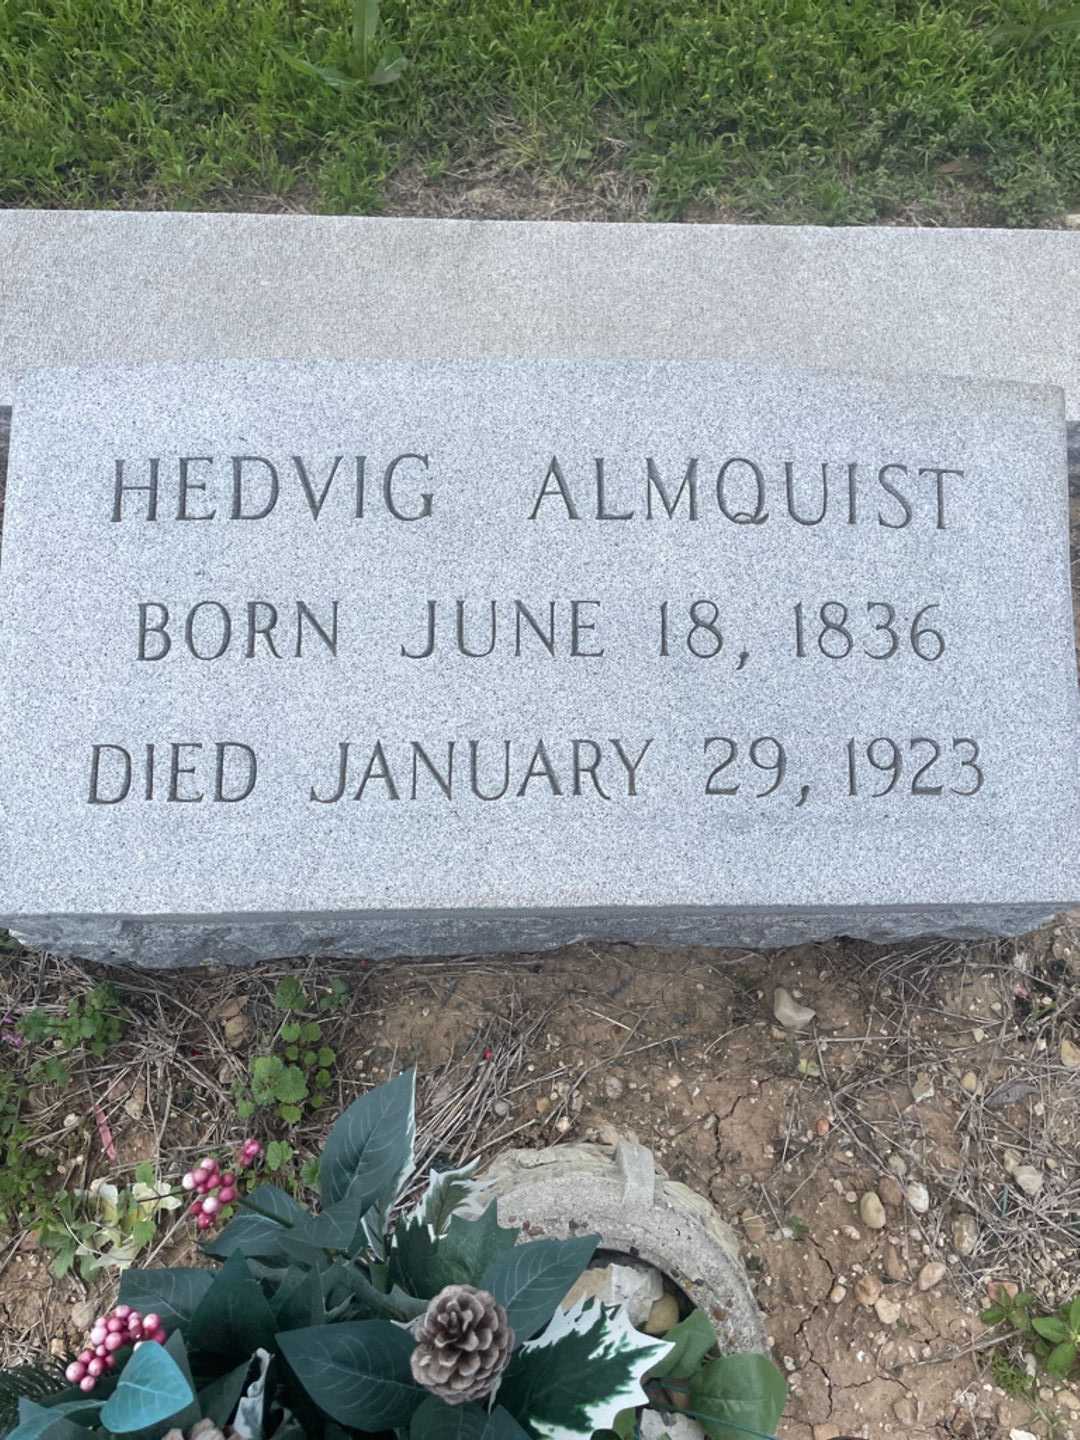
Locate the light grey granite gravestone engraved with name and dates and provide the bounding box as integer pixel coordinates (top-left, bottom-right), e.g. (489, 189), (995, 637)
(0, 361), (1080, 965)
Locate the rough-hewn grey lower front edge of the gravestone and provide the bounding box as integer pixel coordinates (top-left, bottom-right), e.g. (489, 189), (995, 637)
(10, 904), (1054, 969)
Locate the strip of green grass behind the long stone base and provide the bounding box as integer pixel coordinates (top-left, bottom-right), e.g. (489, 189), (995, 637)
(0, 0), (1080, 225)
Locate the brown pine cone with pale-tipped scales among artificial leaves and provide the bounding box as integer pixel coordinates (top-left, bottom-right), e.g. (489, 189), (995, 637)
(412, 1284), (514, 1405)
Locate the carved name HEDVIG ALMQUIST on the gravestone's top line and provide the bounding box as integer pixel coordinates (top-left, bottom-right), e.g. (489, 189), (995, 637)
(111, 451), (963, 530)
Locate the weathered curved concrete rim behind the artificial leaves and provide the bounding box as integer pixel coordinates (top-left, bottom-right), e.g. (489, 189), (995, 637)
(482, 1140), (768, 1352)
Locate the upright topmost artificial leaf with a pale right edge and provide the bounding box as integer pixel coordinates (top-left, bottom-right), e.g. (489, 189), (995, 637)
(318, 1070), (416, 1205)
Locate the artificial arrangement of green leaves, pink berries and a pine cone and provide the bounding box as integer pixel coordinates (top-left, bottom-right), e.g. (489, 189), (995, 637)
(0, 1071), (786, 1440)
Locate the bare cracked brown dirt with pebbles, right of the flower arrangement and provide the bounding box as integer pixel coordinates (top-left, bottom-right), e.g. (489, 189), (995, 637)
(376, 930), (1080, 1440)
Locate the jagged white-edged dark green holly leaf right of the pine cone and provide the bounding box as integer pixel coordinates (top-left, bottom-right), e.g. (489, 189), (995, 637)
(498, 1300), (668, 1440)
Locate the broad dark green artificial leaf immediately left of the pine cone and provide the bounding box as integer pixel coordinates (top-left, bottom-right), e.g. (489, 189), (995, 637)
(278, 1320), (428, 1433)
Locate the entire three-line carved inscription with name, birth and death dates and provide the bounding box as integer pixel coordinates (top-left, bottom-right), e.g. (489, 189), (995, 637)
(84, 444), (992, 816)
